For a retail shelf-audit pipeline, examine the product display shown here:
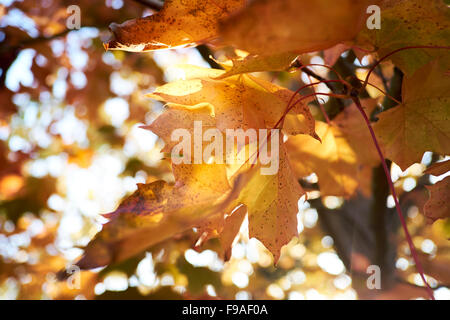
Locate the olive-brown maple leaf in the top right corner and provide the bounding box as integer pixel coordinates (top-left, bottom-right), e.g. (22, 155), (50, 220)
(356, 0), (450, 75)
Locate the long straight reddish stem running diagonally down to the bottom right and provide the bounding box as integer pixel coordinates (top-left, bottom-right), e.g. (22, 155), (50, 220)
(352, 97), (434, 300)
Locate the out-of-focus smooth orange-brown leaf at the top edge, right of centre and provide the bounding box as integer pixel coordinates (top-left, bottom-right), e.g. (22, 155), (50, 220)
(220, 0), (376, 55)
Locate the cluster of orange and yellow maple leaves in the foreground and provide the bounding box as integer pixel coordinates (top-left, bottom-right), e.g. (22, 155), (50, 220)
(80, 1), (450, 267)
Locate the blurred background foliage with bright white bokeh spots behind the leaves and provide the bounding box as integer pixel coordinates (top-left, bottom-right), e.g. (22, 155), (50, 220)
(0, 0), (450, 299)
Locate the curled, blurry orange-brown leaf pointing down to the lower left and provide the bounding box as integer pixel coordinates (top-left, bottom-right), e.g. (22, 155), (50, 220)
(77, 164), (230, 269)
